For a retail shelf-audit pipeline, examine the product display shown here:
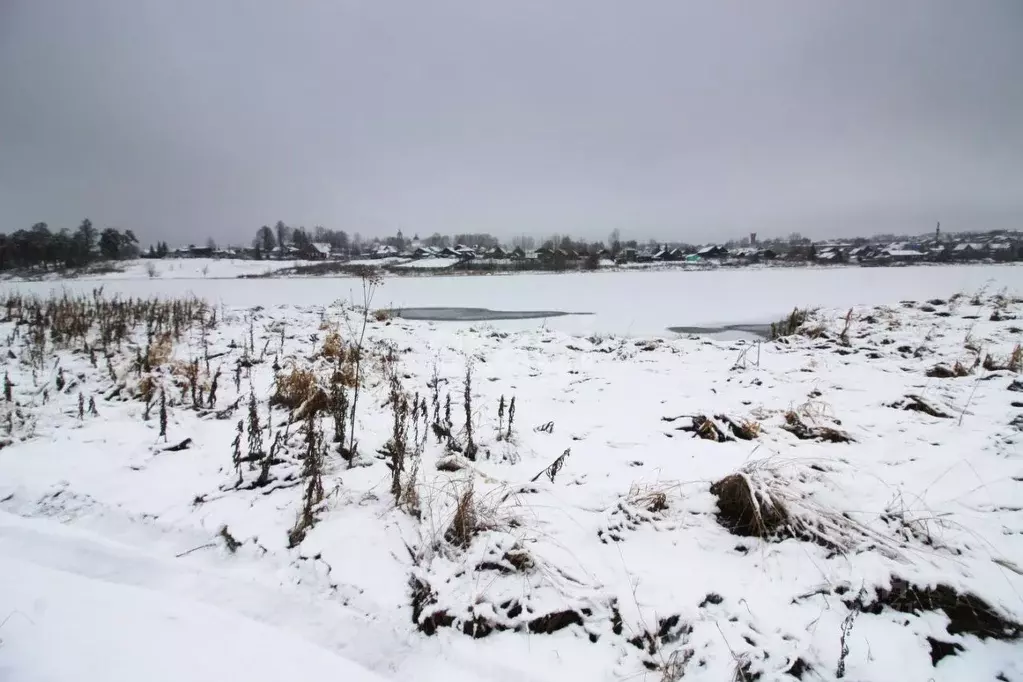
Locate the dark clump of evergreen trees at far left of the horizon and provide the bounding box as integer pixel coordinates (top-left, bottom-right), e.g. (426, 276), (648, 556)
(0, 219), (139, 270)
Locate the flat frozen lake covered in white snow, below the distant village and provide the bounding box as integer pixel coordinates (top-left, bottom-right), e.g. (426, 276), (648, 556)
(0, 264), (1023, 334)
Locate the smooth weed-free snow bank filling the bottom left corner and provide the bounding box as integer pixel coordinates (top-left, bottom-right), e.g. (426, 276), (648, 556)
(0, 513), (384, 682)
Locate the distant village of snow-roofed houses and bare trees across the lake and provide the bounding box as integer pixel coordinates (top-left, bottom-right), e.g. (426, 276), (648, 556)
(157, 223), (1023, 270)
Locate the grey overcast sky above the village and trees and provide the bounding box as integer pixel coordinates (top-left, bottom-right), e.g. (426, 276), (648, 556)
(0, 0), (1023, 244)
